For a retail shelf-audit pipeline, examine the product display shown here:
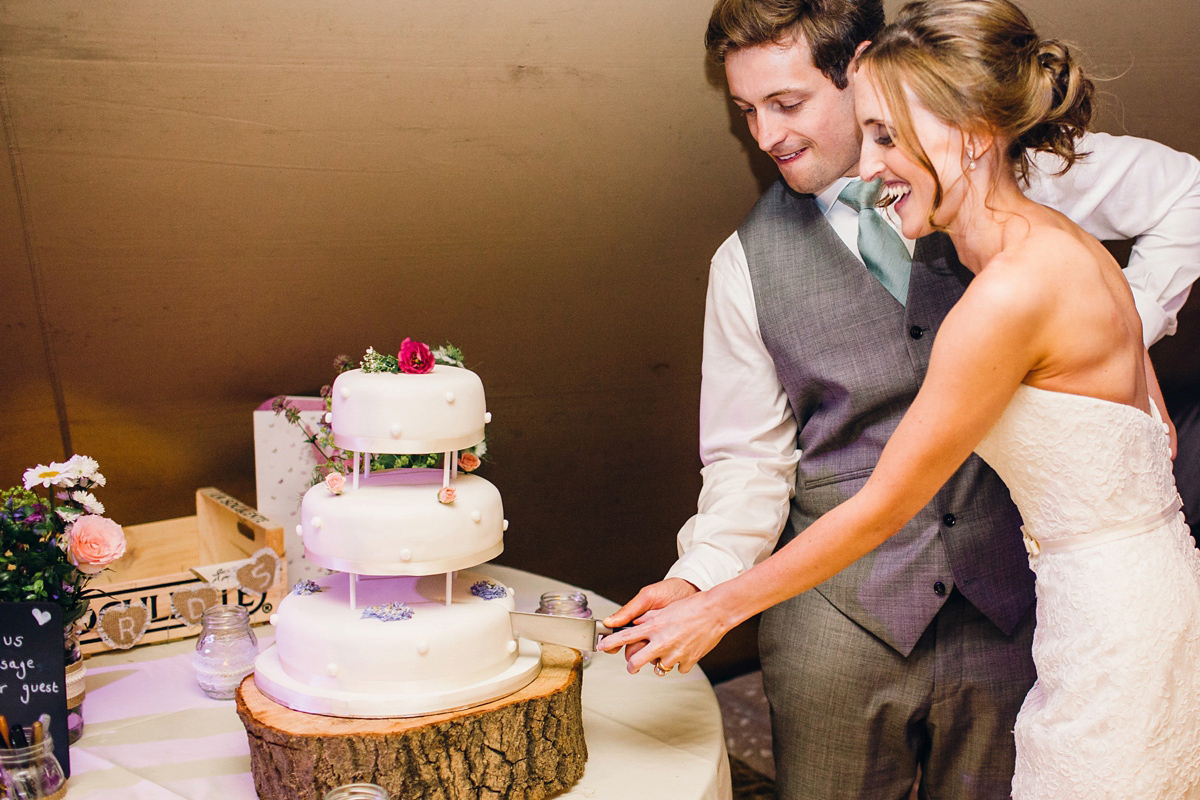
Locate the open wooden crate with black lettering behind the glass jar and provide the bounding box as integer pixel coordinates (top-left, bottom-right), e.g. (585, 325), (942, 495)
(79, 487), (288, 654)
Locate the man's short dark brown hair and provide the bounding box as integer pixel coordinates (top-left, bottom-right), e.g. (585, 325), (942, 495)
(704, 0), (883, 89)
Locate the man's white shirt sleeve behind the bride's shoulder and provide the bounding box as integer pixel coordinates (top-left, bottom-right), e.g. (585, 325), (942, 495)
(1027, 133), (1200, 347)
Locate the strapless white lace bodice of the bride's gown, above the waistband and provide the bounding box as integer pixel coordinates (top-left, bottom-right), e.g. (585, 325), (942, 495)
(976, 384), (1176, 541)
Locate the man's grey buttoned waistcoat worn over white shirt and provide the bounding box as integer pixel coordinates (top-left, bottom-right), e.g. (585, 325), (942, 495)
(738, 181), (1033, 655)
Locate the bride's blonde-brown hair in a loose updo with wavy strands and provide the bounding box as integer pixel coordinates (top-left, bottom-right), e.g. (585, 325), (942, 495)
(859, 0), (1093, 210)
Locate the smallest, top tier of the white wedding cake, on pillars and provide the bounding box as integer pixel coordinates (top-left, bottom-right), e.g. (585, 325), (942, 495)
(331, 365), (488, 453)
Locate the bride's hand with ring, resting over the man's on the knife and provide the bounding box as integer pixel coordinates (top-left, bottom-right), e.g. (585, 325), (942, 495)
(600, 591), (731, 674)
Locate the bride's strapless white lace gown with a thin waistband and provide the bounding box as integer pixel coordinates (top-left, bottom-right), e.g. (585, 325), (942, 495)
(977, 385), (1200, 800)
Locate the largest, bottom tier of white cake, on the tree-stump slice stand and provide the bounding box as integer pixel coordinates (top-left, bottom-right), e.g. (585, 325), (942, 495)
(261, 572), (541, 717)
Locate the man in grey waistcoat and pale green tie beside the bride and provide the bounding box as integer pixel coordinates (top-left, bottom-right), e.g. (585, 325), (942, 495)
(606, 0), (1200, 800)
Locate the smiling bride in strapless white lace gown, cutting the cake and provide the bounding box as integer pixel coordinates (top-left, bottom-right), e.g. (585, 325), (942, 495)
(601, 0), (1200, 800)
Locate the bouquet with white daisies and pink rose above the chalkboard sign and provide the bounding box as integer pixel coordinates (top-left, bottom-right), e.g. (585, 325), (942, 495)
(0, 456), (125, 634)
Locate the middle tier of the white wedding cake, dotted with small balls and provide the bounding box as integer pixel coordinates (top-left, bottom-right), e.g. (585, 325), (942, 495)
(300, 469), (508, 575)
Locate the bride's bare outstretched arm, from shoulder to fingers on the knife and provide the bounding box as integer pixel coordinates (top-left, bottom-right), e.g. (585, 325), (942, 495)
(601, 271), (1044, 672)
